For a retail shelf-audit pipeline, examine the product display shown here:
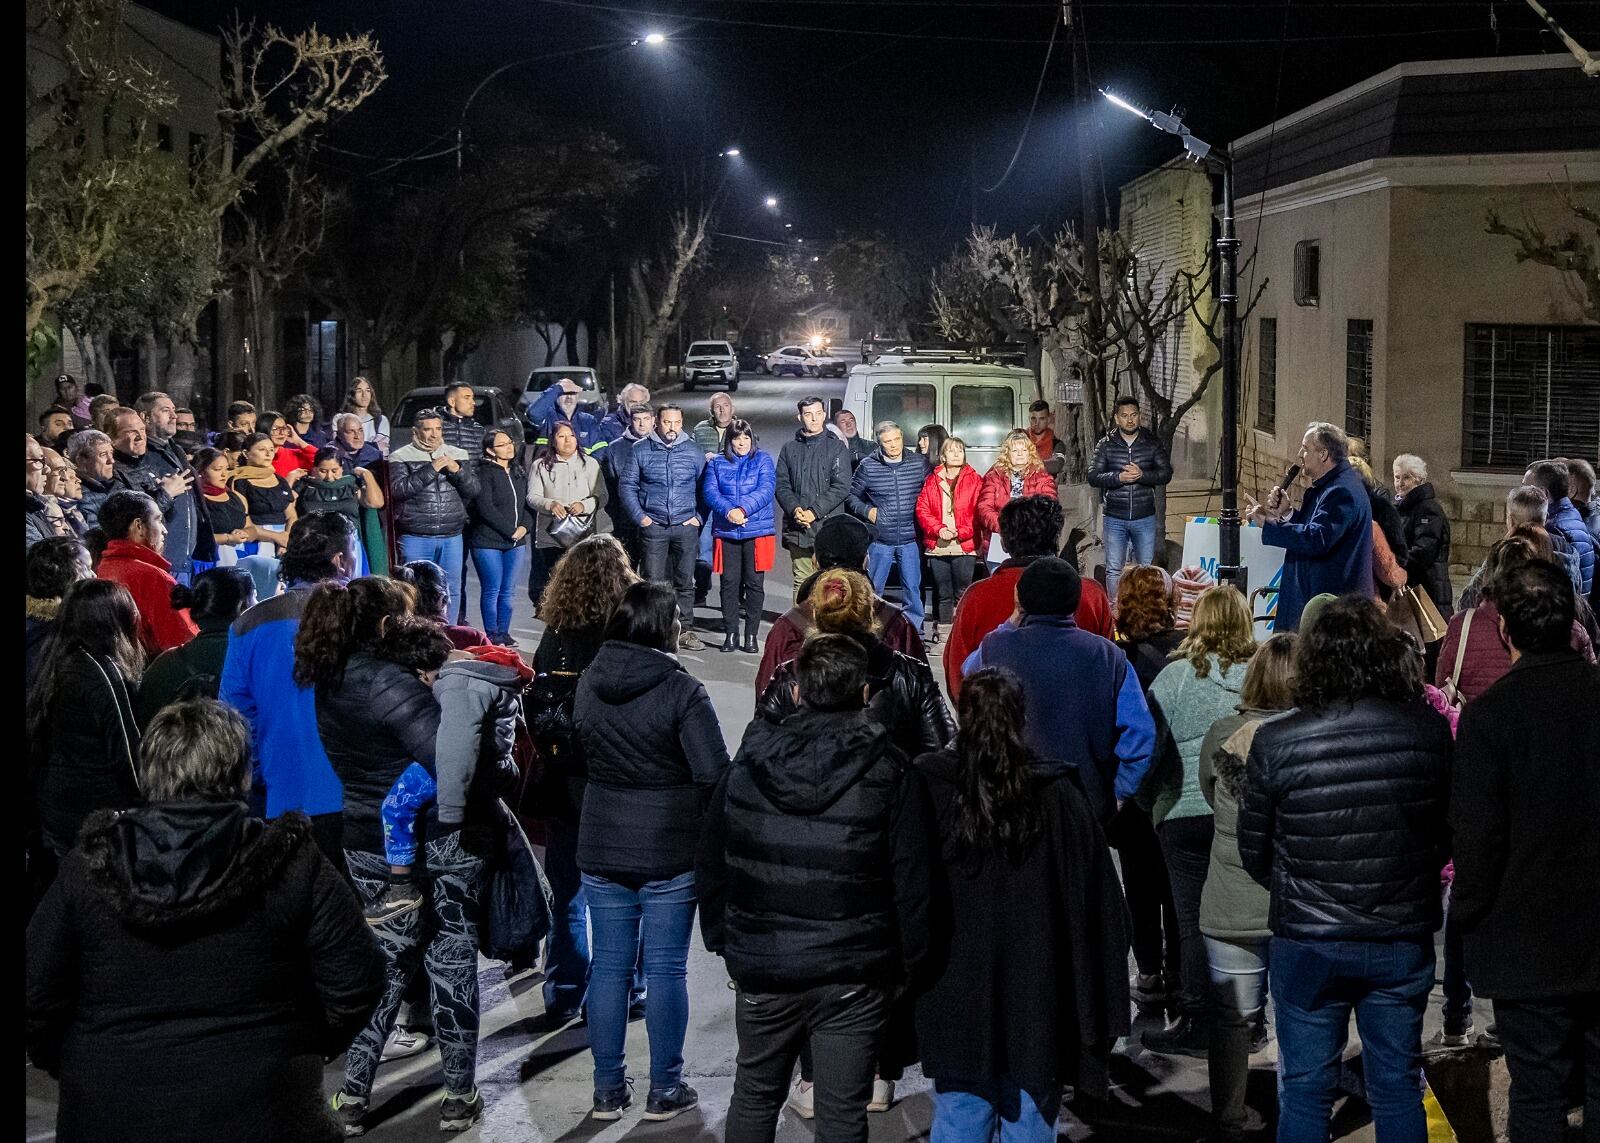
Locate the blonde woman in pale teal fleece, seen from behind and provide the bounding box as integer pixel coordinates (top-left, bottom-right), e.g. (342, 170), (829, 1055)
(1144, 586), (1256, 1057)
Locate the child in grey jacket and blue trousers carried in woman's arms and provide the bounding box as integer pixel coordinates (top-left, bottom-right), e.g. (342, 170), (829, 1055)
(366, 632), (533, 925)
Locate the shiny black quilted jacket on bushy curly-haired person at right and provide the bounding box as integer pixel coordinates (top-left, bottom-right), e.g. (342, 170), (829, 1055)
(1238, 698), (1451, 941)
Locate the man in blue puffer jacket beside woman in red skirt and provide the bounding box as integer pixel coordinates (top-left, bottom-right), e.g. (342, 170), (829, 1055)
(618, 405), (706, 652)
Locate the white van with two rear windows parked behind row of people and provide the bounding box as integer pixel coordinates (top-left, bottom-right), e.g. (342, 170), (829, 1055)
(829, 349), (1037, 472)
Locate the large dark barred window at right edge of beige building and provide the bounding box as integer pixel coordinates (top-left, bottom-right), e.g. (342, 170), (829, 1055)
(1461, 325), (1600, 471)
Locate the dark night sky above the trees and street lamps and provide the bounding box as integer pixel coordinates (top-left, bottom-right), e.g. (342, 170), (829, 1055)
(144, 0), (1600, 245)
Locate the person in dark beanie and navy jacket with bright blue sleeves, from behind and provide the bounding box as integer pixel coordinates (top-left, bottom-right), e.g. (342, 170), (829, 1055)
(962, 555), (1155, 821)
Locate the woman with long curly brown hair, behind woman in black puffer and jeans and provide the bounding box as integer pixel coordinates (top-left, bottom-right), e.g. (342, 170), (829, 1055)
(525, 535), (643, 1023)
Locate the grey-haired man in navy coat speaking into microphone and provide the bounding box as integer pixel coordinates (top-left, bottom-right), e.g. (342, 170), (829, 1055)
(1245, 421), (1373, 631)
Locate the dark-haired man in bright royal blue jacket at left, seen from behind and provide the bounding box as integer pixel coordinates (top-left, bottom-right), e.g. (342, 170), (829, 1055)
(218, 512), (358, 871)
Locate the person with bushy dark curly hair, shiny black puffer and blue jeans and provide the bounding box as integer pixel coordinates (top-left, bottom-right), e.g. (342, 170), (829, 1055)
(1238, 596), (1451, 1140)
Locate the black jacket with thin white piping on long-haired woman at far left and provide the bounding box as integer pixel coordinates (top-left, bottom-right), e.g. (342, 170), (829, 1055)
(29, 648), (139, 855)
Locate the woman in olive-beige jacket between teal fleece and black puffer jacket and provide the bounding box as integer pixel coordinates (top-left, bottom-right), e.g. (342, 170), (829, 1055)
(1200, 631), (1296, 1143)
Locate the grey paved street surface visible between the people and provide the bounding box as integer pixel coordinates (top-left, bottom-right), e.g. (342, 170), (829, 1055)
(27, 375), (1465, 1143)
